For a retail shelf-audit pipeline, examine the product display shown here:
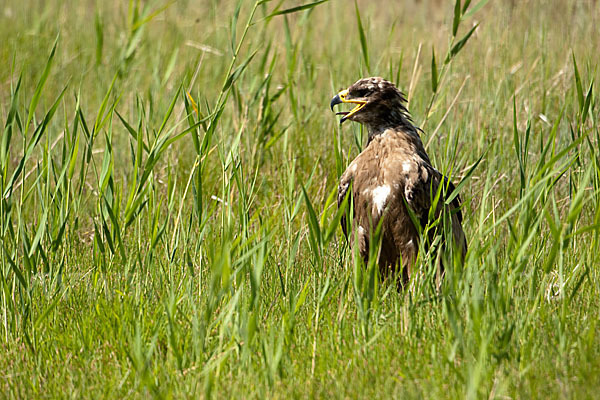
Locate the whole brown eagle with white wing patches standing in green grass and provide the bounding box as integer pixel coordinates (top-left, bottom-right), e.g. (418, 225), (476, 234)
(330, 77), (467, 286)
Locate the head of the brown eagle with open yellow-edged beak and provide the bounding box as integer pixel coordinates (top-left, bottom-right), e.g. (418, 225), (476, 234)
(330, 77), (412, 130)
